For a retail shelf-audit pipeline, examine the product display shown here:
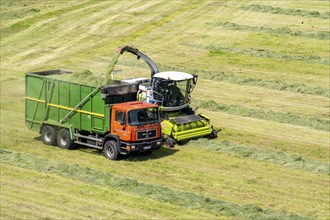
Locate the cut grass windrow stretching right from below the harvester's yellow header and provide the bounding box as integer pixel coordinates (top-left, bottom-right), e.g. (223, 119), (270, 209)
(188, 139), (330, 175)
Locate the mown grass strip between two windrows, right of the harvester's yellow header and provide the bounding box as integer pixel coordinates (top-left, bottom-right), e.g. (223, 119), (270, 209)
(205, 109), (330, 163)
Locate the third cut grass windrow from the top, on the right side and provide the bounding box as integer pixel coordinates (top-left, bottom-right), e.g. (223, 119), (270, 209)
(207, 45), (330, 65)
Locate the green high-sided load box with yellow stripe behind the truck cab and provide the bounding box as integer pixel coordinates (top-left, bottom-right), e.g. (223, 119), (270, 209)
(25, 70), (110, 136)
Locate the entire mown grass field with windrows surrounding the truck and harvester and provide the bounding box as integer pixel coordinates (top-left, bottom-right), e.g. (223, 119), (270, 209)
(0, 0), (330, 219)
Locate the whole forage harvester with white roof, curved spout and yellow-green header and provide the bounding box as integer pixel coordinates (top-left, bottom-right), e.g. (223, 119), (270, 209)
(118, 46), (217, 147)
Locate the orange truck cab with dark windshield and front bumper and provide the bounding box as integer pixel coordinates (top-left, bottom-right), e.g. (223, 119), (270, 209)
(110, 101), (162, 154)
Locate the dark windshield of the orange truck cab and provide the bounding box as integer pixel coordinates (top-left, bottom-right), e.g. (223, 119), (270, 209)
(128, 107), (158, 126)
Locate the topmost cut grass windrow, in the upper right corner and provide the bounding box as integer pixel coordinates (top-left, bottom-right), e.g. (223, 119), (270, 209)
(240, 4), (330, 19)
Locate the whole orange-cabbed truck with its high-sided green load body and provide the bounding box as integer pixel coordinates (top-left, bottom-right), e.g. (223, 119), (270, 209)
(25, 70), (161, 159)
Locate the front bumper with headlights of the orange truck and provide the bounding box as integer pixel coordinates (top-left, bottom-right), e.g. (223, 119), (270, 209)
(120, 138), (163, 154)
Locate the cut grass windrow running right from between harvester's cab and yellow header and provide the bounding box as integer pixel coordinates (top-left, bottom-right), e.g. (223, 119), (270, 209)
(192, 100), (330, 131)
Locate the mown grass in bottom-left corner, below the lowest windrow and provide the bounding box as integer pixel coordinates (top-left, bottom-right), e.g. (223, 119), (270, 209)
(0, 163), (217, 219)
